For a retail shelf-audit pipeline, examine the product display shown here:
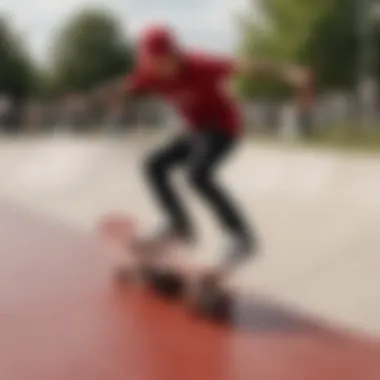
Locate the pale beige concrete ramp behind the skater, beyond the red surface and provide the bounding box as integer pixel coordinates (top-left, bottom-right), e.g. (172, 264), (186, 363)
(0, 137), (380, 334)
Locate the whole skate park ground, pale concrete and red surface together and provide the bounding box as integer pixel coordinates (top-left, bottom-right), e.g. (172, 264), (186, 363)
(0, 135), (380, 380)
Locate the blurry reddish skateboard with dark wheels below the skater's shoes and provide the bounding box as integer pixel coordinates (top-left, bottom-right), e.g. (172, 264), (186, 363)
(98, 214), (231, 319)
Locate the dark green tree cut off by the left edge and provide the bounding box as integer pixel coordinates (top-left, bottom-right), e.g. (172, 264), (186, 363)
(0, 18), (36, 100)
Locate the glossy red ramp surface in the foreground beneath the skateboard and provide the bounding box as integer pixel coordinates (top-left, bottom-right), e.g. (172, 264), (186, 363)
(0, 206), (380, 380)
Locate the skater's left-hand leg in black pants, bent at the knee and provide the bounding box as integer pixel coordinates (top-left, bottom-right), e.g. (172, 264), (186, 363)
(145, 135), (193, 239)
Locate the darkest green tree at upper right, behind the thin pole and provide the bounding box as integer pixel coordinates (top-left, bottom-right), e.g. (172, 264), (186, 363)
(300, 0), (380, 89)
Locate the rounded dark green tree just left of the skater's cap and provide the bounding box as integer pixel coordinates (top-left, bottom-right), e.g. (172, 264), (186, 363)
(48, 9), (132, 92)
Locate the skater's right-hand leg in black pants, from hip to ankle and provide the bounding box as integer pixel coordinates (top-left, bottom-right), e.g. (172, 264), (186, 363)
(188, 132), (255, 262)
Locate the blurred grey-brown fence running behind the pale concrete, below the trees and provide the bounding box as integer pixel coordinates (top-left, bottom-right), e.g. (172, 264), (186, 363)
(0, 94), (380, 135)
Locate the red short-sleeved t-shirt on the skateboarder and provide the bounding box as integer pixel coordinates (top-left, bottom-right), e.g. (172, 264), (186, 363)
(127, 53), (242, 136)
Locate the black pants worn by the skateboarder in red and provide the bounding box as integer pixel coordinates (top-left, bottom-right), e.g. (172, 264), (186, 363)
(145, 131), (250, 243)
